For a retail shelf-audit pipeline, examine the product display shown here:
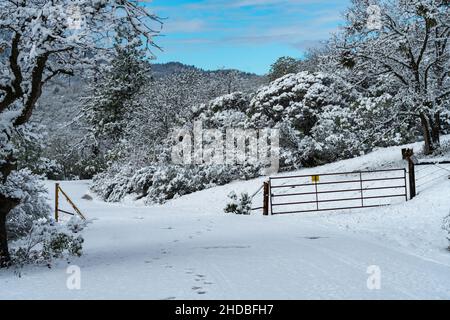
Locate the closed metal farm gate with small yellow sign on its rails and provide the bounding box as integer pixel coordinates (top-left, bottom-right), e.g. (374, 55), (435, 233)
(266, 169), (408, 215)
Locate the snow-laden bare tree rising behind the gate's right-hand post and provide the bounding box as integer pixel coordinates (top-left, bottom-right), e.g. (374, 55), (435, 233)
(335, 0), (450, 154)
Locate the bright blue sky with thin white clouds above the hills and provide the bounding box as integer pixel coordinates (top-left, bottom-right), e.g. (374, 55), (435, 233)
(149, 0), (349, 74)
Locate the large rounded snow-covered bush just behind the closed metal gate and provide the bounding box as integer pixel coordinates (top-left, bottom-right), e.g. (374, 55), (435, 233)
(246, 72), (414, 168)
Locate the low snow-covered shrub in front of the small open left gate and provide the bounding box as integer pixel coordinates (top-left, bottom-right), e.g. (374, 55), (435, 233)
(11, 217), (86, 266)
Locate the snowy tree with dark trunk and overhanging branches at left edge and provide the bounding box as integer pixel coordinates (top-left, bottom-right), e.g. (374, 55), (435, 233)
(0, 0), (160, 266)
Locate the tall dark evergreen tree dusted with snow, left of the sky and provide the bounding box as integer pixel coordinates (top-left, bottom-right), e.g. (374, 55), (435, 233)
(81, 26), (150, 172)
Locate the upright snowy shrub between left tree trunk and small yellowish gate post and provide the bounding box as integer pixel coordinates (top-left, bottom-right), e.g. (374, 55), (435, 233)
(4, 169), (51, 240)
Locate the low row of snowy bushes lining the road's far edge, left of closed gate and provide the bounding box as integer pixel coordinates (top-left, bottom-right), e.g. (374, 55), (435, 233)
(91, 164), (260, 204)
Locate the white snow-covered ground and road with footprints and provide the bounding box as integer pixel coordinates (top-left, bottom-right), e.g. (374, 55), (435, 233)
(0, 144), (450, 299)
